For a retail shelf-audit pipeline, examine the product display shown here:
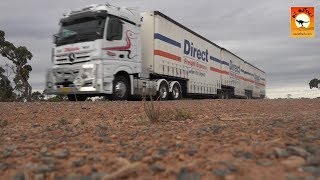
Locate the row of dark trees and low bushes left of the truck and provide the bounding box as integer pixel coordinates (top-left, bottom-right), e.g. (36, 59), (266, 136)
(0, 30), (41, 101)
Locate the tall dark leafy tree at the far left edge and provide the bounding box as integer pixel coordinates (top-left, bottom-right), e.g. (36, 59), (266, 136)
(0, 30), (33, 101)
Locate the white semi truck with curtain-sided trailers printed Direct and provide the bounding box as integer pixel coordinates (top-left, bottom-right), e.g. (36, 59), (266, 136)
(45, 4), (266, 101)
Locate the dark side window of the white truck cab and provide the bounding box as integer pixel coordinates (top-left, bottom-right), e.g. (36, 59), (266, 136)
(107, 17), (123, 41)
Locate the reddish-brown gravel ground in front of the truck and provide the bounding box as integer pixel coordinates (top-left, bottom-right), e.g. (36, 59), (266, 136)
(0, 100), (320, 180)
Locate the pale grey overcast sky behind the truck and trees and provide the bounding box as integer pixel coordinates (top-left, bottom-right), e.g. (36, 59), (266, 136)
(0, 0), (320, 98)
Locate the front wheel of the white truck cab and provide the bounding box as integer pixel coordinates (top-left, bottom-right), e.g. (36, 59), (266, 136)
(112, 76), (130, 101)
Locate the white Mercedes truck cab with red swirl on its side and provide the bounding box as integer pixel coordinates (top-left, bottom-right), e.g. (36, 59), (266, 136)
(45, 5), (142, 101)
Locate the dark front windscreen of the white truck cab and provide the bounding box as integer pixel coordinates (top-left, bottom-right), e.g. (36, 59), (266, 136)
(55, 17), (106, 46)
